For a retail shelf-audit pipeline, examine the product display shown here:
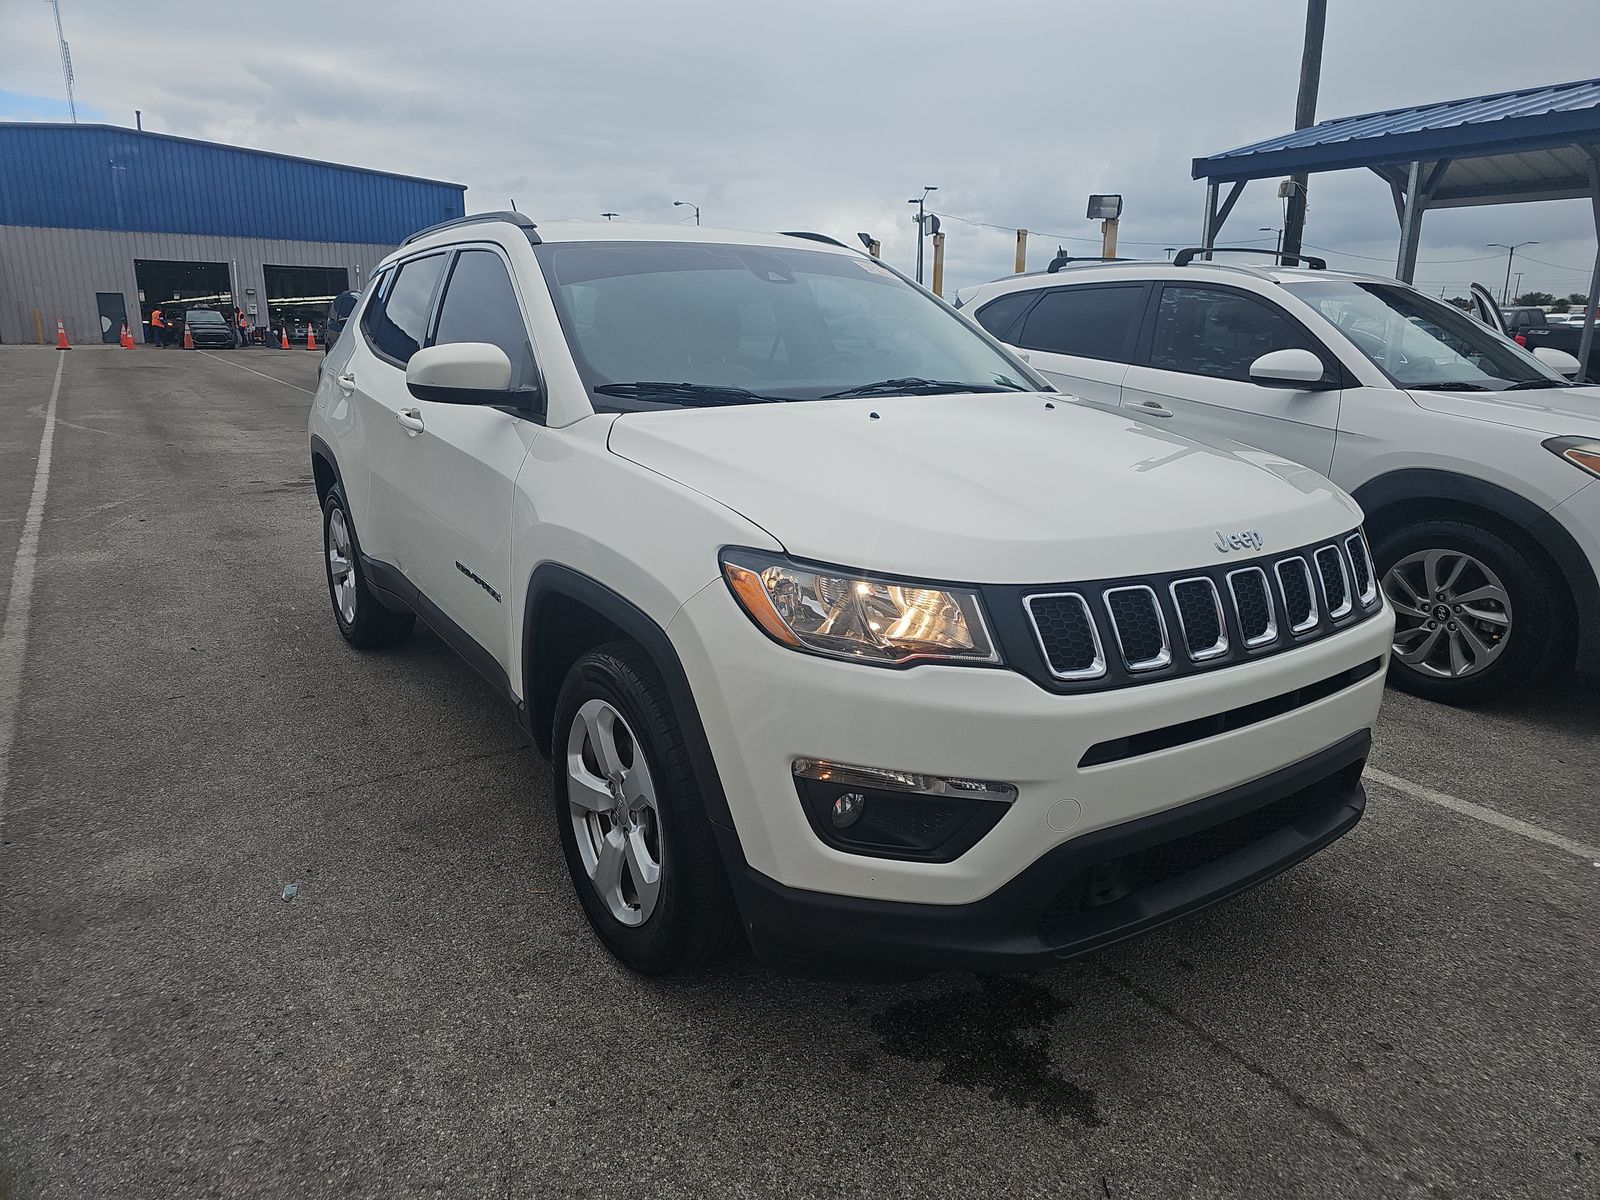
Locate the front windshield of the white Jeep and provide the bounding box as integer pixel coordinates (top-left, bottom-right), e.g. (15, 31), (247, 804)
(536, 242), (1048, 411)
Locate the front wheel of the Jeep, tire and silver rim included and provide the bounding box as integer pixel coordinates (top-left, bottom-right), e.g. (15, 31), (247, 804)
(550, 642), (739, 974)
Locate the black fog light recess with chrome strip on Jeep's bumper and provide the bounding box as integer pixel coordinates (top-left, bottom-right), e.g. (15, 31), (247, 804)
(794, 758), (1016, 862)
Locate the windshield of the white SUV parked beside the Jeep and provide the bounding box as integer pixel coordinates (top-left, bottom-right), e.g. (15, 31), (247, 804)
(1283, 280), (1566, 392)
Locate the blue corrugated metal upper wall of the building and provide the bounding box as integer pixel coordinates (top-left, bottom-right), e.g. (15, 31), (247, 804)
(0, 122), (466, 245)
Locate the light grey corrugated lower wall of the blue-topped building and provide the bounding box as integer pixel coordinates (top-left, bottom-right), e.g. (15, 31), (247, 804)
(0, 226), (398, 346)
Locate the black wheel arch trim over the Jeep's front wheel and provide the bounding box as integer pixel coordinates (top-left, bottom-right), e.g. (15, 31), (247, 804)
(522, 563), (747, 880)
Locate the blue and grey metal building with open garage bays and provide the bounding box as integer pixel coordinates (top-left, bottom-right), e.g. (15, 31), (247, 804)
(0, 123), (466, 342)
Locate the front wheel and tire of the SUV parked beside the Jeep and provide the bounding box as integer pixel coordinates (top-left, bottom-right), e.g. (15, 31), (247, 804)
(1373, 520), (1571, 704)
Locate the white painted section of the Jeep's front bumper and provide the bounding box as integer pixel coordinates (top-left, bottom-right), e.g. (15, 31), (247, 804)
(667, 579), (1394, 906)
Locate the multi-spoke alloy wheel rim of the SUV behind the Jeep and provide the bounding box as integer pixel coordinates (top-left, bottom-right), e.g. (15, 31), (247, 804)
(1384, 550), (1512, 678)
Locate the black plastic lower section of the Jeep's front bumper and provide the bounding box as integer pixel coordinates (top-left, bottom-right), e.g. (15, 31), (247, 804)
(734, 730), (1371, 973)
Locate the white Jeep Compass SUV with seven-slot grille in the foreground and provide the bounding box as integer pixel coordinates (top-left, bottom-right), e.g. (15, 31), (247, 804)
(310, 213), (1394, 973)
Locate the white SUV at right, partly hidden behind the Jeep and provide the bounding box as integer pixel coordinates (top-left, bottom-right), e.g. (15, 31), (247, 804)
(962, 248), (1600, 704)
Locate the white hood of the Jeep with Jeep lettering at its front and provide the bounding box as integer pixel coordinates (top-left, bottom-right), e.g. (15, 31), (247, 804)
(610, 392), (1360, 584)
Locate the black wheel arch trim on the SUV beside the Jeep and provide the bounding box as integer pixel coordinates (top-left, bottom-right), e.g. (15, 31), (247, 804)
(1354, 467), (1600, 672)
